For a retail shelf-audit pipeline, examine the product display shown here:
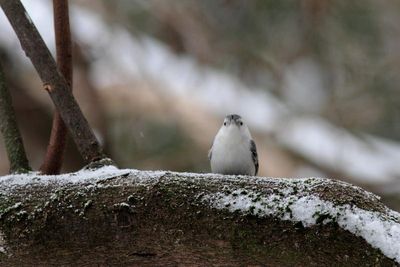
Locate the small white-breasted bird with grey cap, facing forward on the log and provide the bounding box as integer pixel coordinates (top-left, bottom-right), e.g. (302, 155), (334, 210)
(208, 114), (258, 176)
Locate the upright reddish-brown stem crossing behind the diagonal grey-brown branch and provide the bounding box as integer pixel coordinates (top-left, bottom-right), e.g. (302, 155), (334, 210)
(40, 0), (73, 174)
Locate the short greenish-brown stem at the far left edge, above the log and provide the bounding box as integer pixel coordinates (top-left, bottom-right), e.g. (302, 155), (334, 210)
(0, 61), (31, 173)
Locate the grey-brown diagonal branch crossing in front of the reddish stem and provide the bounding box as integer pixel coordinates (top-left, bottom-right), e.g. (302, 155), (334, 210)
(0, 0), (105, 163)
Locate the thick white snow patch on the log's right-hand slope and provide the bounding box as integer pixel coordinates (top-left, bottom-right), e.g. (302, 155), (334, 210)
(202, 182), (400, 263)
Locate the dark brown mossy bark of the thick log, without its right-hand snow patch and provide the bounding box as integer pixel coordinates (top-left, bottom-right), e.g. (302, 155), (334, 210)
(0, 170), (397, 266)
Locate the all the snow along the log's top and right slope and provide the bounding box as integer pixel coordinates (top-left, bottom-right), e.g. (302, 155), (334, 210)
(0, 166), (400, 263)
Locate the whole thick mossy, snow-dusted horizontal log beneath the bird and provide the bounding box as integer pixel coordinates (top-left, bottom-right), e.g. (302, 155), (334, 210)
(0, 166), (400, 265)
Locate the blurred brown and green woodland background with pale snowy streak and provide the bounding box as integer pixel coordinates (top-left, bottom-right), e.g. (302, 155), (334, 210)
(0, 0), (400, 210)
